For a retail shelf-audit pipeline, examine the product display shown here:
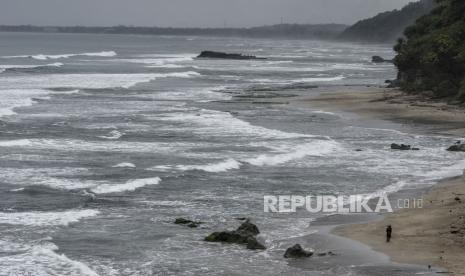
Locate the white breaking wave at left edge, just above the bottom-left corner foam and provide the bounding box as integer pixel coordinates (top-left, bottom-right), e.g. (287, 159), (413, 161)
(0, 209), (100, 226)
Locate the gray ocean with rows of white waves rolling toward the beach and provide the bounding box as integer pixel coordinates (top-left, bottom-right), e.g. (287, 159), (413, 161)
(0, 33), (465, 276)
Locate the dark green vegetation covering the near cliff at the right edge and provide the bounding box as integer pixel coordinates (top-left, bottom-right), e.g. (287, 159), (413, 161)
(394, 0), (465, 102)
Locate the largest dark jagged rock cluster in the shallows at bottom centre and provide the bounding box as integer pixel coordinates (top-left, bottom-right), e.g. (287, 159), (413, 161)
(205, 220), (266, 250)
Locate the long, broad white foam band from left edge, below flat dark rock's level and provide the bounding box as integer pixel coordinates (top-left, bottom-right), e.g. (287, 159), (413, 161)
(0, 71), (200, 89)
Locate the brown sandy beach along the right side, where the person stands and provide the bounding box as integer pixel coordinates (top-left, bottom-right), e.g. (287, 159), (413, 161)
(292, 88), (465, 275)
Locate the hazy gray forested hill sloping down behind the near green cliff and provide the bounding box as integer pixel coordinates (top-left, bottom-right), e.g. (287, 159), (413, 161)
(340, 0), (435, 42)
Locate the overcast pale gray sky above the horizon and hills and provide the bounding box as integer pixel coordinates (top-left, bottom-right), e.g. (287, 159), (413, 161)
(0, 0), (415, 27)
